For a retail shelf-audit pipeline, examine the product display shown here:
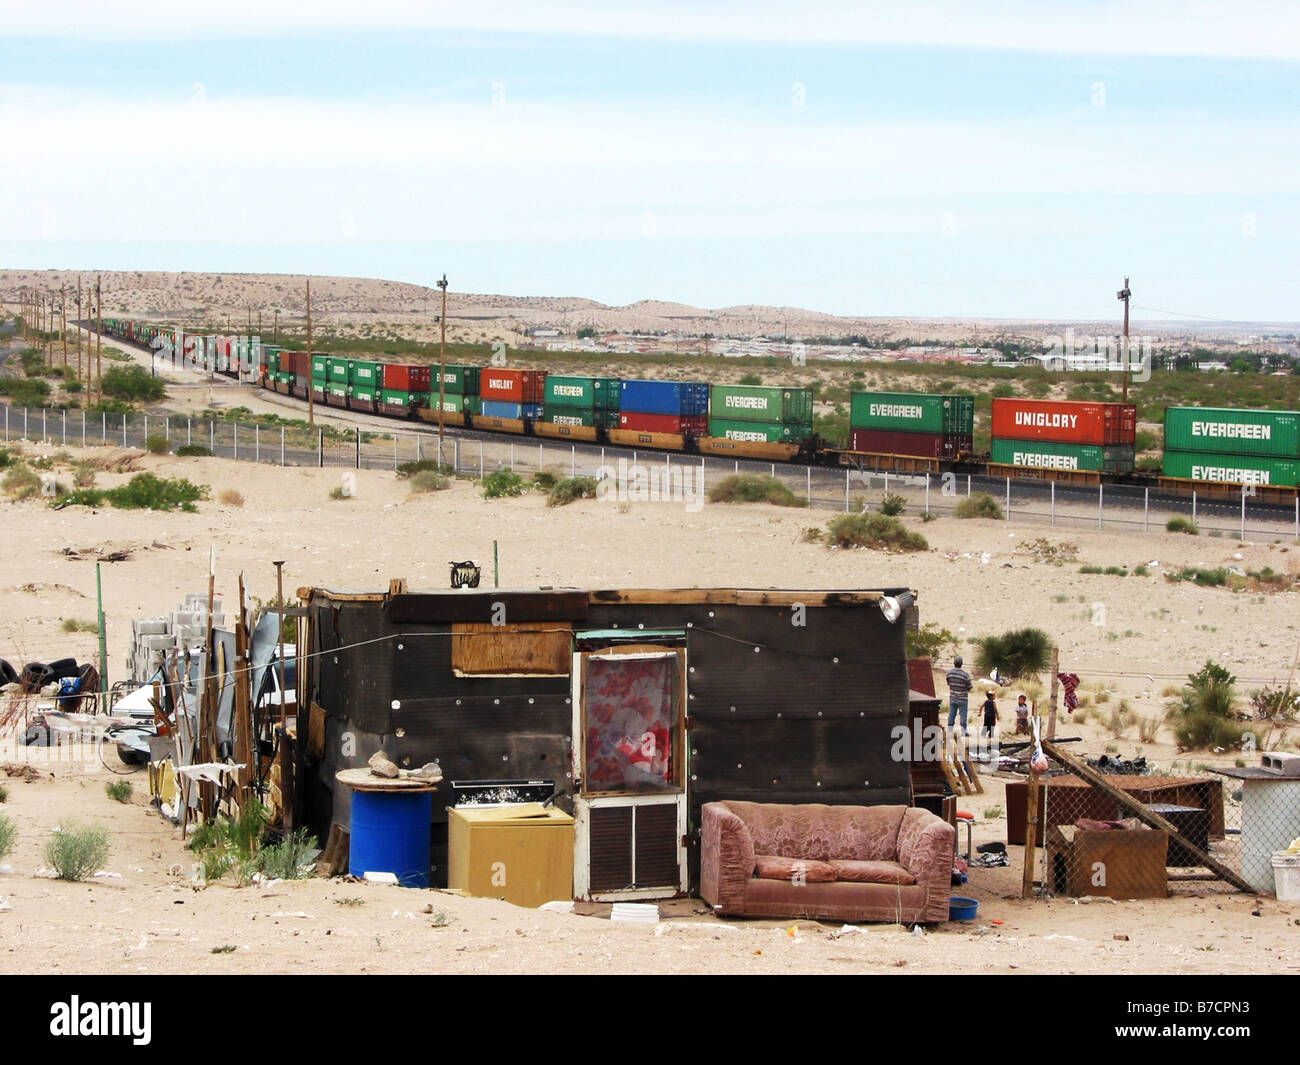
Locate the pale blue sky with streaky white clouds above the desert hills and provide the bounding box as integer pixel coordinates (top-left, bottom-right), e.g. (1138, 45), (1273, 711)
(0, 0), (1300, 321)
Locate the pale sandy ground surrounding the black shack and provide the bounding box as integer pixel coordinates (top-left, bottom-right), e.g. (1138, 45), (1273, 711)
(0, 449), (1300, 973)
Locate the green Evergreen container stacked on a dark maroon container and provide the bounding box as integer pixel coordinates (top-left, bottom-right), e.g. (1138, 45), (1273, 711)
(849, 391), (975, 459)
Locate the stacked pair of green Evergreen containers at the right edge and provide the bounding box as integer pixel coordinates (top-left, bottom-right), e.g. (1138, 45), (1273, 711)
(1164, 407), (1300, 488)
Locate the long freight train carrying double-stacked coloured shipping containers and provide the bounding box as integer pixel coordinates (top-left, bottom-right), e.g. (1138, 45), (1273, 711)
(91, 319), (1300, 503)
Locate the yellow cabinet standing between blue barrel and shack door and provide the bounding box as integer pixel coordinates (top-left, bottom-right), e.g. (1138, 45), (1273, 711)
(447, 802), (573, 906)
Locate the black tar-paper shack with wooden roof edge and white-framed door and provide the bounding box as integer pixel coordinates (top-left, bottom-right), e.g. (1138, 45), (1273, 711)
(294, 581), (914, 899)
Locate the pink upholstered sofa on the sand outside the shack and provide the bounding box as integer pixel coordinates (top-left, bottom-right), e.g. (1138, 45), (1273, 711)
(699, 802), (956, 923)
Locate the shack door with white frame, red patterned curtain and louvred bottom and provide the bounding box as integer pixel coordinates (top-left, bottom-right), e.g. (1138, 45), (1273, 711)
(573, 635), (688, 901)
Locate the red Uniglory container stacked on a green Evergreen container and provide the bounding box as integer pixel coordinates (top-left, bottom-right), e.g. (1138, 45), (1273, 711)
(991, 398), (1138, 473)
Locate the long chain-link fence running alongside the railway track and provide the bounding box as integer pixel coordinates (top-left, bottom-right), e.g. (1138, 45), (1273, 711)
(3, 406), (1300, 541)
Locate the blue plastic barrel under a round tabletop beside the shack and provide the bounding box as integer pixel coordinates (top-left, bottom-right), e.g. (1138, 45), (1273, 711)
(348, 791), (433, 887)
